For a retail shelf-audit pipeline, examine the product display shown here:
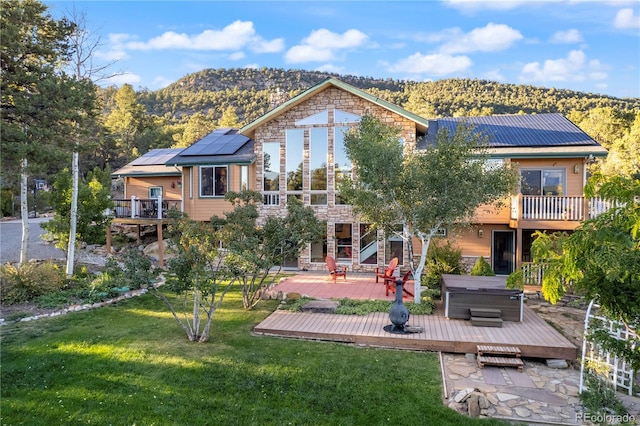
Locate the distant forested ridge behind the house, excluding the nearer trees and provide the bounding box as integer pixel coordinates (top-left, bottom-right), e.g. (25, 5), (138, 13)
(139, 68), (640, 124)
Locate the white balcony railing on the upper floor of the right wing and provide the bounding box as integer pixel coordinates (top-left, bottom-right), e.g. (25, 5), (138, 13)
(511, 194), (617, 221)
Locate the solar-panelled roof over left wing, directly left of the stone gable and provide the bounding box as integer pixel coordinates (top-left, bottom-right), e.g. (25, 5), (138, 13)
(166, 128), (256, 166)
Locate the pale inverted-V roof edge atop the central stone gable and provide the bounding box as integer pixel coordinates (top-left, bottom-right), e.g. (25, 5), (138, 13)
(239, 78), (429, 135)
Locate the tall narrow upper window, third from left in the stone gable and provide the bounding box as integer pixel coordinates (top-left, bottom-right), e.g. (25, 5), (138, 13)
(309, 127), (329, 204)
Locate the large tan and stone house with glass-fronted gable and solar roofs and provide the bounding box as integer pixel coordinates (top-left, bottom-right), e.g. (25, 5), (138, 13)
(116, 78), (606, 274)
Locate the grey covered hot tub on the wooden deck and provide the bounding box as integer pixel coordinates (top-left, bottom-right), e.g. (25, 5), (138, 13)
(442, 274), (523, 321)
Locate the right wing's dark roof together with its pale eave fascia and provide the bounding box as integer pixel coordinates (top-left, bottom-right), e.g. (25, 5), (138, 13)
(419, 113), (607, 157)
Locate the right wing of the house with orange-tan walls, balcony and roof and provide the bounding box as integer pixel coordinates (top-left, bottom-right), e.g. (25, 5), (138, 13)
(418, 113), (607, 278)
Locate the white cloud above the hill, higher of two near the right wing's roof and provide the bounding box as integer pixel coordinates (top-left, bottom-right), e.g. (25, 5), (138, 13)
(439, 22), (524, 54)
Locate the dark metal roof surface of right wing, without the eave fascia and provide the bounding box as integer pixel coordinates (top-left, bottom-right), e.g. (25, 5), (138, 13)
(426, 113), (600, 148)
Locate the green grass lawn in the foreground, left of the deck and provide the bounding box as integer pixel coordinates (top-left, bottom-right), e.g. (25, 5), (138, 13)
(0, 294), (504, 426)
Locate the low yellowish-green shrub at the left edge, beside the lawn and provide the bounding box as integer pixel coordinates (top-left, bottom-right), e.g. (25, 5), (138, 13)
(0, 262), (64, 305)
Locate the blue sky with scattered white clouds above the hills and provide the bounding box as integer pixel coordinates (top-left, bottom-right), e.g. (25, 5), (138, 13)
(45, 0), (640, 97)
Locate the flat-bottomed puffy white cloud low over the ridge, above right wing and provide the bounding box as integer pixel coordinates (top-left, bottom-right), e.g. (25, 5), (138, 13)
(520, 50), (608, 83)
